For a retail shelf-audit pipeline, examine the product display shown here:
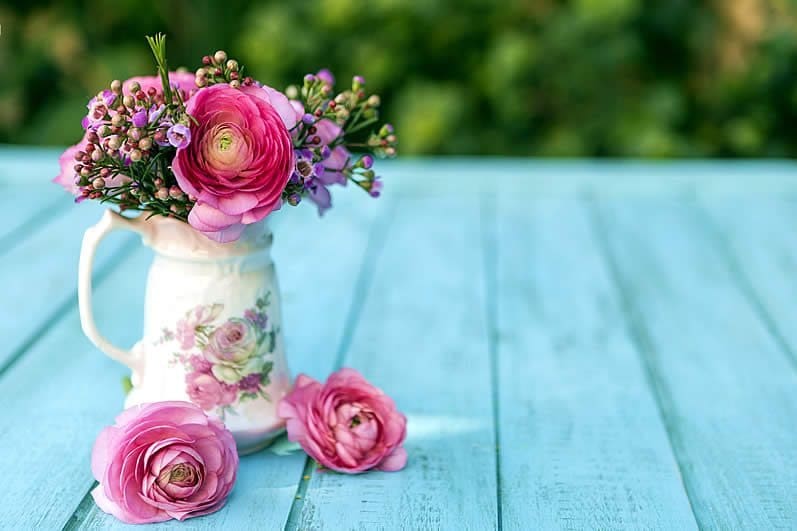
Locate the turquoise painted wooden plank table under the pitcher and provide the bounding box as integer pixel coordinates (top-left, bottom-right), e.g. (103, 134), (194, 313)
(0, 148), (797, 530)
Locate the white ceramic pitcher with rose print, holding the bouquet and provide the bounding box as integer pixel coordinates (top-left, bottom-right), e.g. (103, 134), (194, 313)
(78, 210), (291, 454)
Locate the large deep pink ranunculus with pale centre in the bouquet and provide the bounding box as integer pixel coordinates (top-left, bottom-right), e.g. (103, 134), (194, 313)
(172, 84), (296, 243)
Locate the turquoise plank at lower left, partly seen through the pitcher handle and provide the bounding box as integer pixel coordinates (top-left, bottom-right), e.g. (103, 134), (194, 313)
(0, 249), (149, 529)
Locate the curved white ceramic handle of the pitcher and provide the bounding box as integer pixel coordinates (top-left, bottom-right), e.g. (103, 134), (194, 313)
(78, 210), (151, 371)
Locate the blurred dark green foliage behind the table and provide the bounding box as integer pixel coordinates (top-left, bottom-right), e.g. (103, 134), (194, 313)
(0, 0), (797, 157)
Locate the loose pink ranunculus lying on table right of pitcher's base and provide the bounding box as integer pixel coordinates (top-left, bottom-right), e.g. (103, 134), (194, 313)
(277, 369), (407, 474)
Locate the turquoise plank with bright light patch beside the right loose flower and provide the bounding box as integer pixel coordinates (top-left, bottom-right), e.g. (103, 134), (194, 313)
(287, 196), (497, 529)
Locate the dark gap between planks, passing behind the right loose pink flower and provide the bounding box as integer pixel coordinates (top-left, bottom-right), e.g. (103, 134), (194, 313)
(284, 199), (400, 530)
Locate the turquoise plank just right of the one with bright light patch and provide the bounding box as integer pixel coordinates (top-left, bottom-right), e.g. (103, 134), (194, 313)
(496, 196), (696, 530)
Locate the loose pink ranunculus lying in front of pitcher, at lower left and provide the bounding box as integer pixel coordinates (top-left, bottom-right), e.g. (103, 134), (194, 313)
(91, 402), (238, 524)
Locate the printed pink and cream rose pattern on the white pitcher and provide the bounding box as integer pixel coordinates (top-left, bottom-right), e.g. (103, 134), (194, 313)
(159, 293), (278, 418)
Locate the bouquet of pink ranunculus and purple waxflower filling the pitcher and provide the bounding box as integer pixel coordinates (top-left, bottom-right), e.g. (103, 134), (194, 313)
(55, 35), (396, 243)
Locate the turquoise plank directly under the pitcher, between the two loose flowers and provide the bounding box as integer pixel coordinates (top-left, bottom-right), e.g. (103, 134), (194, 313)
(64, 190), (386, 530)
